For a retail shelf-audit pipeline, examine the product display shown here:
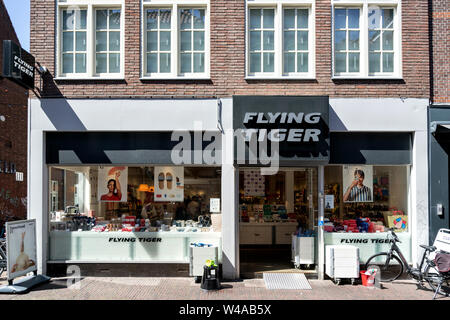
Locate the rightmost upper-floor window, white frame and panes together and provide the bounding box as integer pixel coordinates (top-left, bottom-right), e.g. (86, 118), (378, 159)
(333, 1), (401, 78)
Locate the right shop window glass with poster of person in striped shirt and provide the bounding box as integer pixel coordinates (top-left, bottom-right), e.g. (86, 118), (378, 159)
(324, 165), (409, 233)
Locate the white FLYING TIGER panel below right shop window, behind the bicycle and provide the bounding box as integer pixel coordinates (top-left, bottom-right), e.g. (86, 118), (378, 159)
(324, 232), (412, 264)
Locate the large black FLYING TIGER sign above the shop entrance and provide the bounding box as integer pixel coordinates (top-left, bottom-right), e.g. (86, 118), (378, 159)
(233, 96), (330, 165)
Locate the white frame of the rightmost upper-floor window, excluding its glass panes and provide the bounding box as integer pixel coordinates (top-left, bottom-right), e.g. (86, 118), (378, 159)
(331, 0), (403, 80)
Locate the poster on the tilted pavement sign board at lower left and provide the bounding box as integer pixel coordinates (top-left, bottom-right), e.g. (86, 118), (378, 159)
(6, 219), (37, 280)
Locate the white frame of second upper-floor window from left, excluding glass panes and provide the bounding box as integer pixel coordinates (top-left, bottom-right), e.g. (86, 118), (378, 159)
(141, 0), (211, 80)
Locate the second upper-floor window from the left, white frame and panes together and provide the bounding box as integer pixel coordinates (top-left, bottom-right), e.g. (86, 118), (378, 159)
(142, 0), (209, 79)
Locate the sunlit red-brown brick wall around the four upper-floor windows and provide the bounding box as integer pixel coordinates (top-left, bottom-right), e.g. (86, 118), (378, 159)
(31, 0), (430, 98)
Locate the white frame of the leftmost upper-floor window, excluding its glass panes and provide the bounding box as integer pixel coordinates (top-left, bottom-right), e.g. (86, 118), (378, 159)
(55, 0), (125, 80)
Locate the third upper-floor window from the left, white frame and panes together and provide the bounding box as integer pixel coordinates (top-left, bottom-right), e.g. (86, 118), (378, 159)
(247, 1), (315, 79)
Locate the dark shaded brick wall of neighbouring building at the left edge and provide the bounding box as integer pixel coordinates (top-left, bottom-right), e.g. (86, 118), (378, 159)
(0, 0), (28, 222)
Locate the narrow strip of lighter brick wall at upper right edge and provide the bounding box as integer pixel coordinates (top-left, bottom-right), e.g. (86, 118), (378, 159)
(431, 0), (450, 103)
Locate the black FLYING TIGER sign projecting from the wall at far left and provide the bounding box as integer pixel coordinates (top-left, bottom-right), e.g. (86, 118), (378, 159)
(2, 40), (35, 89)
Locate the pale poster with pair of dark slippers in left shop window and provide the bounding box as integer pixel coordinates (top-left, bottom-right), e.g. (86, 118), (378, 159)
(155, 167), (184, 202)
